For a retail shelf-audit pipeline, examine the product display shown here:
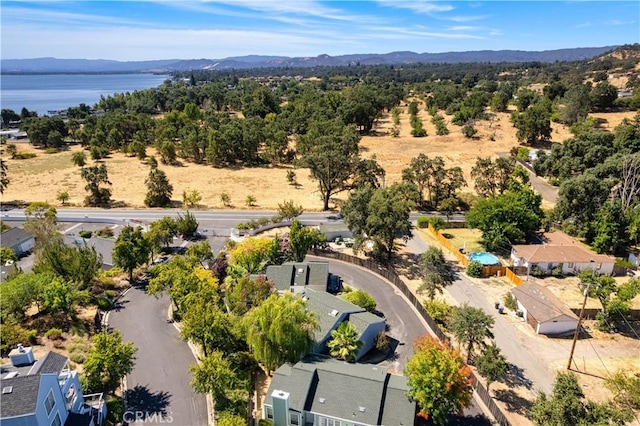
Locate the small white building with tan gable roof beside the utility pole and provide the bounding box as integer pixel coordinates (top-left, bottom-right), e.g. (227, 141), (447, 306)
(511, 282), (578, 335)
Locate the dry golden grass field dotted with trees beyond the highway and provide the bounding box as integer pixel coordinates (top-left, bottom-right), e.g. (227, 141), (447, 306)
(2, 105), (634, 210)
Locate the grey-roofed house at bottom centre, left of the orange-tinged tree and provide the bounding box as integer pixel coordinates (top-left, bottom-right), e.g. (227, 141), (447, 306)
(262, 355), (417, 426)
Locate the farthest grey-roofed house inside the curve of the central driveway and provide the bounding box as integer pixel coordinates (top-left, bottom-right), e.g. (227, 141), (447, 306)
(265, 262), (342, 293)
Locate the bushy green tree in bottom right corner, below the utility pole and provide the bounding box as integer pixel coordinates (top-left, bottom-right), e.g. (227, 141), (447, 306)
(530, 371), (633, 426)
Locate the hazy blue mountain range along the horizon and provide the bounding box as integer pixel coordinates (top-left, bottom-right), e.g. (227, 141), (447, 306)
(0, 46), (617, 74)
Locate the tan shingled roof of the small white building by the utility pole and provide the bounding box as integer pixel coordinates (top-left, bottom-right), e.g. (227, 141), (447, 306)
(511, 282), (578, 323)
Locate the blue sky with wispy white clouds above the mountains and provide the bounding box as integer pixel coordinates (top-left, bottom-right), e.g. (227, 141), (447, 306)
(0, 0), (640, 60)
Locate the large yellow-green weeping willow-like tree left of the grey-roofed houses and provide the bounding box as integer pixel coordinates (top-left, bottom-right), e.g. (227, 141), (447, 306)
(244, 293), (317, 371)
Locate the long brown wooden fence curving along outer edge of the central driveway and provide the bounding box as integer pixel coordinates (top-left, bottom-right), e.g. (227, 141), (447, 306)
(309, 250), (511, 426)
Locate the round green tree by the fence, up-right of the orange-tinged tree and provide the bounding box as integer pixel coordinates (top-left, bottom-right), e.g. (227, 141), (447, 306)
(449, 303), (495, 362)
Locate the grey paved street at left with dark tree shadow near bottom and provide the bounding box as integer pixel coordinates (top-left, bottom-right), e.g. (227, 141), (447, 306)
(109, 287), (207, 426)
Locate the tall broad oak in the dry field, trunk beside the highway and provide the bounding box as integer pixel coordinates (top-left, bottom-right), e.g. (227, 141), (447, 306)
(297, 120), (360, 210)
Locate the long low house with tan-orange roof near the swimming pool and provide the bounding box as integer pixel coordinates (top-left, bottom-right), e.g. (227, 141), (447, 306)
(511, 232), (616, 275)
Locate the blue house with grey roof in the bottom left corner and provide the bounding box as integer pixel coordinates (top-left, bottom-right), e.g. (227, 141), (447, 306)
(0, 346), (107, 426)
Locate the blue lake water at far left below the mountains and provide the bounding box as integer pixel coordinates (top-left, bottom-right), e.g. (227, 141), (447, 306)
(0, 74), (171, 115)
